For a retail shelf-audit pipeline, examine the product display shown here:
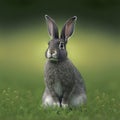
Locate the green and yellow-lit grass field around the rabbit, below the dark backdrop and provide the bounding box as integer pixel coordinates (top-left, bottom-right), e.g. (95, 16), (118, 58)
(0, 26), (120, 120)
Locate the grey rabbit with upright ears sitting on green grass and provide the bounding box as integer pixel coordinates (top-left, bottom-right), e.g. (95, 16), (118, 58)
(42, 15), (87, 107)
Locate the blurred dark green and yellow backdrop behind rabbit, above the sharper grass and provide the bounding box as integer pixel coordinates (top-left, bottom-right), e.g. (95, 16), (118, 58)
(0, 0), (120, 119)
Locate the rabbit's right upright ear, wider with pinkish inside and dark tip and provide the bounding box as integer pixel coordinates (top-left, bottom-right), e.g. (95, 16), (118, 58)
(61, 16), (77, 40)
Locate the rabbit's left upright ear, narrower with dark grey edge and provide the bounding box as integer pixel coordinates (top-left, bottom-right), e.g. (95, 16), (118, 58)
(45, 15), (59, 38)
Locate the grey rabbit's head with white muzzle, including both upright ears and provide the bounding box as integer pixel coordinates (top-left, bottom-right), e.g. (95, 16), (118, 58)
(45, 15), (77, 62)
